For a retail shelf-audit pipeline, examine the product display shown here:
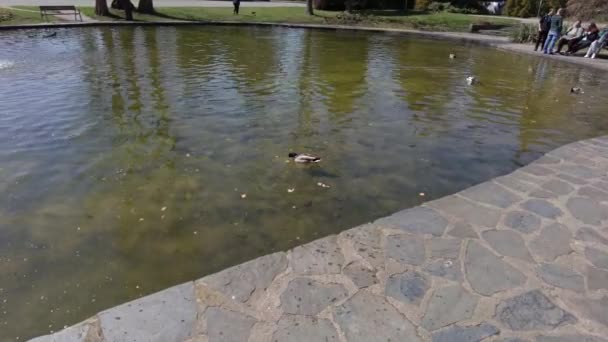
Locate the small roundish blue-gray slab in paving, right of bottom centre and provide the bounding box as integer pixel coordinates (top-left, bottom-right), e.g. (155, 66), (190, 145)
(385, 271), (430, 305)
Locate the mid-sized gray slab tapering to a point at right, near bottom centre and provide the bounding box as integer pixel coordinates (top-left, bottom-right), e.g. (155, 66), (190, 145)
(281, 278), (348, 315)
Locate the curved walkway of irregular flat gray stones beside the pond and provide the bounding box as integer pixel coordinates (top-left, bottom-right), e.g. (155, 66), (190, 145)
(30, 137), (608, 342)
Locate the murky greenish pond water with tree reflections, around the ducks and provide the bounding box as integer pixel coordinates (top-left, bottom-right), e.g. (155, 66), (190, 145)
(0, 27), (608, 341)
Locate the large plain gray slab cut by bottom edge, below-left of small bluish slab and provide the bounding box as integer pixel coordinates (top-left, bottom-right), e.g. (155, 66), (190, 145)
(334, 291), (422, 342)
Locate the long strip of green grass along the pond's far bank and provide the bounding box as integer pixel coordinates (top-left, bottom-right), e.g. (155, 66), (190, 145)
(73, 7), (518, 31)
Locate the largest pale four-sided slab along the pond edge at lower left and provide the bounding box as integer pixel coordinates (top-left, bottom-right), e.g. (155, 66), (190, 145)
(98, 282), (197, 342)
